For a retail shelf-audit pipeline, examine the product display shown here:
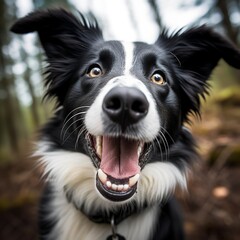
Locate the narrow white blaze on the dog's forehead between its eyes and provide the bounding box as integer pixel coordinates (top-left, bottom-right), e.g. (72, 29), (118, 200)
(121, 42), (134, 75)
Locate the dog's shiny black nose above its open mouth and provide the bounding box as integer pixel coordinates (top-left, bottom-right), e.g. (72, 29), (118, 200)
(102, 87), (149, 130)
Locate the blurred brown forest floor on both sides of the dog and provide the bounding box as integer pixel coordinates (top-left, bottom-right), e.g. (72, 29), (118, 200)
(0, 100), (240, 240)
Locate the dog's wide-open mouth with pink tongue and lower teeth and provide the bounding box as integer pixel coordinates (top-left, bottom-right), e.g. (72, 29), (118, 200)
(87, 135), (149, 202)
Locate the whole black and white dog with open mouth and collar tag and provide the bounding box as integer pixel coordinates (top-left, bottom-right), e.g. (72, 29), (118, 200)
(11, 9), (240, 240)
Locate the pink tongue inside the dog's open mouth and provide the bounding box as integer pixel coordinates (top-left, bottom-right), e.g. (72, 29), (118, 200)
(100, 137), (140, 179)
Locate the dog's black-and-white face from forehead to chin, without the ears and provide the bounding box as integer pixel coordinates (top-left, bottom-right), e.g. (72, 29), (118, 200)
(70, 42), (181, 201)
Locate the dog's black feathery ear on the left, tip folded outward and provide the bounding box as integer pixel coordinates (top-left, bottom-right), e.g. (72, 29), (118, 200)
(11, 9), (103, 103)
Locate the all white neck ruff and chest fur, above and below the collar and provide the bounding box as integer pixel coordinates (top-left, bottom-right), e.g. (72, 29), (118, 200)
(36, 142), (186, 240)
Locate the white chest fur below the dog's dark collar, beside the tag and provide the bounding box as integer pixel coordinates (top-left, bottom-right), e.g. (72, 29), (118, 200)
(47, 192), (158, 240)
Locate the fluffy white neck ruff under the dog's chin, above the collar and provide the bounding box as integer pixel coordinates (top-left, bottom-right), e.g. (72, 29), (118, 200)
(36, 142), (186, 211)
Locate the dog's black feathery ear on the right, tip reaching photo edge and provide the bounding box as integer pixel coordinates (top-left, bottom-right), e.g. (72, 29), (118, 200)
(156, 26), (240, 117)
